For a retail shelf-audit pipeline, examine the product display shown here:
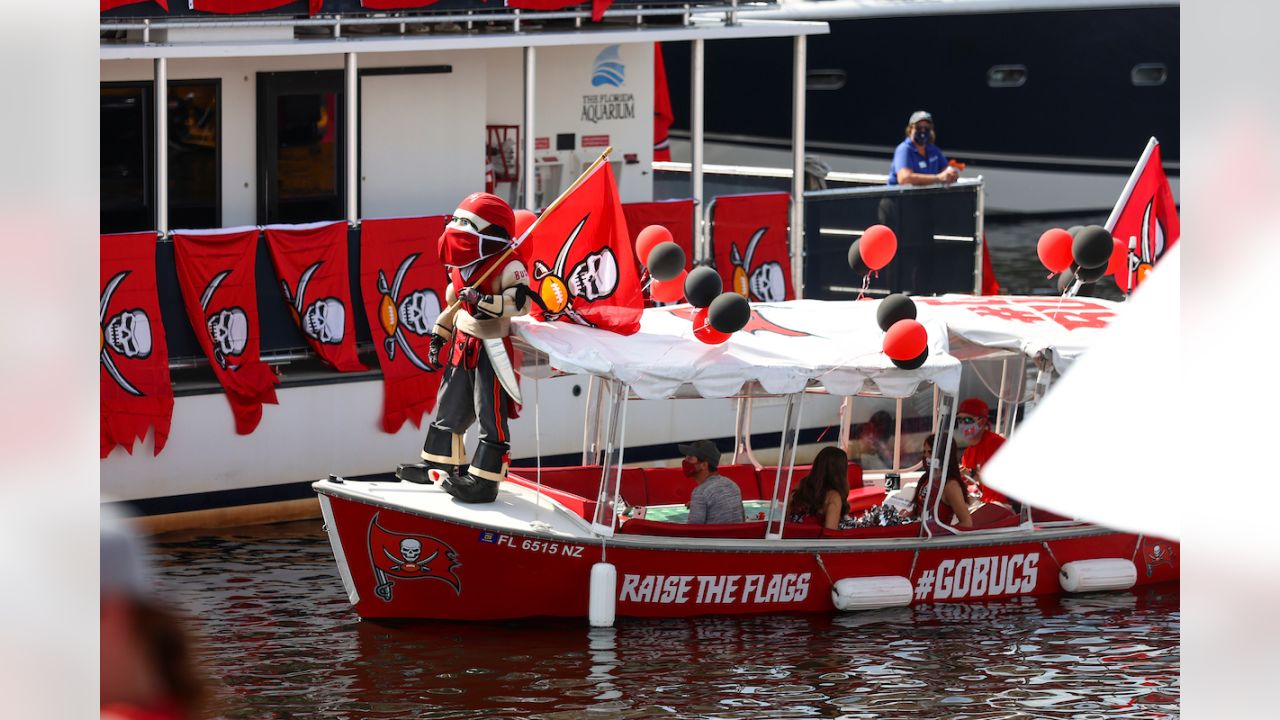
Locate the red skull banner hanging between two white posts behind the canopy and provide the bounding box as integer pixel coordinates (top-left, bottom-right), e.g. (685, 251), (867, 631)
(712, 192), (796, 302)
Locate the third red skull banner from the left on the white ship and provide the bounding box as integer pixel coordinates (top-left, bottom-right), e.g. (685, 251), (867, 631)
(266, 220), (365, 373)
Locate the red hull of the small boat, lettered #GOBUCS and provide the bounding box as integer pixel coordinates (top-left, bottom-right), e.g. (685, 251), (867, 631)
(321, 481), (1179, 620)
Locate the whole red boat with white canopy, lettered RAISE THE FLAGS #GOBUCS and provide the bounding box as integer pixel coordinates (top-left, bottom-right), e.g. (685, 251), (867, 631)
(314, 296), (1179, 624)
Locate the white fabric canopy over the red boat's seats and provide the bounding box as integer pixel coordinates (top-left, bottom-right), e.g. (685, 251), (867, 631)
(513, 295), (1116, 400)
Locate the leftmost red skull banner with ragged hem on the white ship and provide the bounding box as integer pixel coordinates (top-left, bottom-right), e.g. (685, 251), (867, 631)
(97, 232), (173, 457)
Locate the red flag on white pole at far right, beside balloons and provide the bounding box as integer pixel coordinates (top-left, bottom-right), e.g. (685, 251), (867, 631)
(1106, 137), (1181, 292)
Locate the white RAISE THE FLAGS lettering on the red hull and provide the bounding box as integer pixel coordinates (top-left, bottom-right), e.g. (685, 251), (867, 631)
(618, 573), (810, 605)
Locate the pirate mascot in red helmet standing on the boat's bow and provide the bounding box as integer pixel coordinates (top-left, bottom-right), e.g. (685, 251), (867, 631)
(397, 192), (535, 502)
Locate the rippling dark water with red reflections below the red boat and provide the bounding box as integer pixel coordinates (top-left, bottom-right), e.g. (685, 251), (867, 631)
(156, 521), (1180, 719)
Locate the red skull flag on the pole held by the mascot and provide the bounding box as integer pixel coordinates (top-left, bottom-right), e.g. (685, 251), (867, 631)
(524, 163), (644, 334)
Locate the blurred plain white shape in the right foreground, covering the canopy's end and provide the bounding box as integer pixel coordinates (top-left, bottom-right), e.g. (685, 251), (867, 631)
(983, 243), (1182, 539)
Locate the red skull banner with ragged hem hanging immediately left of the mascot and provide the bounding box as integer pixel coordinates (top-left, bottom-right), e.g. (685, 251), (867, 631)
(360, 215), (448, 433)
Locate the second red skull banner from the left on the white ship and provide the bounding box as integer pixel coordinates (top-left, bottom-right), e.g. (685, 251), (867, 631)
(173, 228), (279, 436)
